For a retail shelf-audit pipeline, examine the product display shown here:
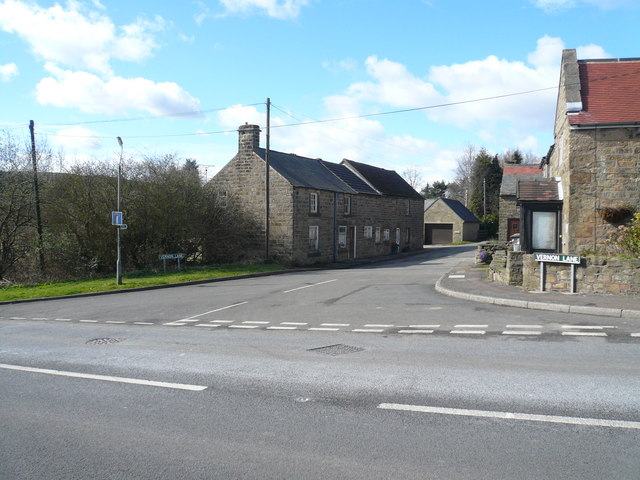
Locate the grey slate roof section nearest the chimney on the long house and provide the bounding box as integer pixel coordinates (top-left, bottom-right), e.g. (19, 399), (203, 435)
(256, 148), (356, 193)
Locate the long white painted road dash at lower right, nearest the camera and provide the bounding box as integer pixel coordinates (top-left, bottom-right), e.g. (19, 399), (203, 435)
(378, 403), (640, 430)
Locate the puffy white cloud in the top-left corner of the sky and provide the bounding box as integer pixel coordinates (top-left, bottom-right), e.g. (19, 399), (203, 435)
(0, 0), (165, 75)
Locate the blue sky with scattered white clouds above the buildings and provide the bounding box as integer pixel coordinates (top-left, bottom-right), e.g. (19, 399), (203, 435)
(0, 0), (640, 186)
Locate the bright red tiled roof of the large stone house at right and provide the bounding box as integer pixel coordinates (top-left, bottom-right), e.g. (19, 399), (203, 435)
(569, 59), (640, 125)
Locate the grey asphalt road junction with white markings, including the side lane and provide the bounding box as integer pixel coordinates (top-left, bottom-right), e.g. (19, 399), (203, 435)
(0, 249), (640, 479)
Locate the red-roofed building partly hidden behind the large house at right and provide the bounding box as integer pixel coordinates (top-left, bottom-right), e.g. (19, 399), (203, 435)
(498, 165), (544, 242)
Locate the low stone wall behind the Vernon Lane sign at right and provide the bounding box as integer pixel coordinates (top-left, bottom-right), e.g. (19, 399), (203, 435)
(523, 255), (640, 295)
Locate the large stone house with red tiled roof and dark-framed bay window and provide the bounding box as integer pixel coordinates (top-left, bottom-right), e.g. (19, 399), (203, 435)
(517, 50), (640, 255)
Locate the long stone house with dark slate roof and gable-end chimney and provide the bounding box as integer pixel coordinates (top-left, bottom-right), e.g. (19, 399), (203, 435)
(210, 125), (423, 265)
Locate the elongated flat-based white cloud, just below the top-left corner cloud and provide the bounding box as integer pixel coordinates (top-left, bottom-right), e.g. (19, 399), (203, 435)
(36, 63), (200, 115)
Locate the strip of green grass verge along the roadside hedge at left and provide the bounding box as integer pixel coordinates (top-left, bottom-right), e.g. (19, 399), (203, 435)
(0, 264), (284, 301)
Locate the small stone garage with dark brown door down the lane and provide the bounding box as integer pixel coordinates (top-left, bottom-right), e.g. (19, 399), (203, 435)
(424, 198), (480, 245)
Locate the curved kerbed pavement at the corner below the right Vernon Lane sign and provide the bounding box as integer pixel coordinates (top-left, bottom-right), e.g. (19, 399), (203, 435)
(436, 261), (640, 320)
